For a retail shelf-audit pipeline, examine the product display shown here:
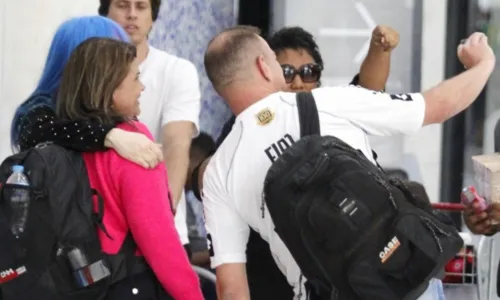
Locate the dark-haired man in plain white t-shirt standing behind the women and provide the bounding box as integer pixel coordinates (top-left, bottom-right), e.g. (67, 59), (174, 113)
(99, 0), (200, 245)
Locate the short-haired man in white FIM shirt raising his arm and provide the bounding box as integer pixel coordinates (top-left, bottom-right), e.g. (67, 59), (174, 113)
(202, 26), (495, 300)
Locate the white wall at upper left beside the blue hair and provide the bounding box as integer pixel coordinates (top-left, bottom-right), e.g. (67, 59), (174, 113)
(0, 0), (99, 160)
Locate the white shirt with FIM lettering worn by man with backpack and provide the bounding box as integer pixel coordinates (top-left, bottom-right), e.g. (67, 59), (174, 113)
(203, 86), (425, 297)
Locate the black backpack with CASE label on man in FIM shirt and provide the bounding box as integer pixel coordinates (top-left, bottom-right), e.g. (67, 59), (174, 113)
(264, 93), (463, 300)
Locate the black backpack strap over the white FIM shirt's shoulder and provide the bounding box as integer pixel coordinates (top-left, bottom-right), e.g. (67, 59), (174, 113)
(297, 92), (321, 137)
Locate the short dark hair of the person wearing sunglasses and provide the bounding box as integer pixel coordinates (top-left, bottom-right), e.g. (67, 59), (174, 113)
(267, 27), (323, 66)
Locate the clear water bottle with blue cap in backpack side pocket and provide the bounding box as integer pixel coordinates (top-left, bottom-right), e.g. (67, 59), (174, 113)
(6, 165), (30, 236)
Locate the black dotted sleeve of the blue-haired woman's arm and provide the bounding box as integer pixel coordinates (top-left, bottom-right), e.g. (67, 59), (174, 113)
(18, 105), (114, 152)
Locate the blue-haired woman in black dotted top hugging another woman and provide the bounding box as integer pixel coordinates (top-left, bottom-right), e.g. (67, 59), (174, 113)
(11, 16), (163, 168)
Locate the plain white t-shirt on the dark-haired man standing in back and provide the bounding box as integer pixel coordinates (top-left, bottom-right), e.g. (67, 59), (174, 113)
(139, 46), (200, 245)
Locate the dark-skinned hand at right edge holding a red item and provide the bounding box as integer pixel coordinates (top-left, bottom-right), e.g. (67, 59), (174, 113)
(464, 202), (500, 235)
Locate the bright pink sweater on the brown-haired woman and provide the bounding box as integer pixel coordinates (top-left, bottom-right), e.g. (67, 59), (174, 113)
(84, 122), (203, 300)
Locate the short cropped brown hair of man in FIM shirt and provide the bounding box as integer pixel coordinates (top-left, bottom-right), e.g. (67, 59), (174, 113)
(204, 25), (260, 89)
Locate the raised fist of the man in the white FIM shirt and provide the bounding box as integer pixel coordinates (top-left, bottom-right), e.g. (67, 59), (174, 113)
(457, 32), (495, 69)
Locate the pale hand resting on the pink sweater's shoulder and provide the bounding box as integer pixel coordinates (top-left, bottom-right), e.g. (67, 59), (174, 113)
(106, 128), (163, 168)
